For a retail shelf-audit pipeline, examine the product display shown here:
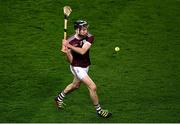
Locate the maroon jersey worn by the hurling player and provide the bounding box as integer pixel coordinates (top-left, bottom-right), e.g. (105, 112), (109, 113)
(68, 33), (94, 68)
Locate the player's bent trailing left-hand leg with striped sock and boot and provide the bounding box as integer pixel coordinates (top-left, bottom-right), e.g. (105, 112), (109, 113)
(55, 77), (81, 109)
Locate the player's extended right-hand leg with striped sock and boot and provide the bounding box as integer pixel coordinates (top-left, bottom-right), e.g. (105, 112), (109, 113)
(82, 75), (112, 118)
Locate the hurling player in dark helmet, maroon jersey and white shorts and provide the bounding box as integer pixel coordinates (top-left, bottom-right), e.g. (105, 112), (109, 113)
(55, 20), (112, 118)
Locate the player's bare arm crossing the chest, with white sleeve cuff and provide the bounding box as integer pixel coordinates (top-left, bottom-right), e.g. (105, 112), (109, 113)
(64, 41), (91, 55)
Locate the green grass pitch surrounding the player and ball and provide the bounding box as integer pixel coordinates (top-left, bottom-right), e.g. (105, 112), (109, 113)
(0, 0), (180, 123)
